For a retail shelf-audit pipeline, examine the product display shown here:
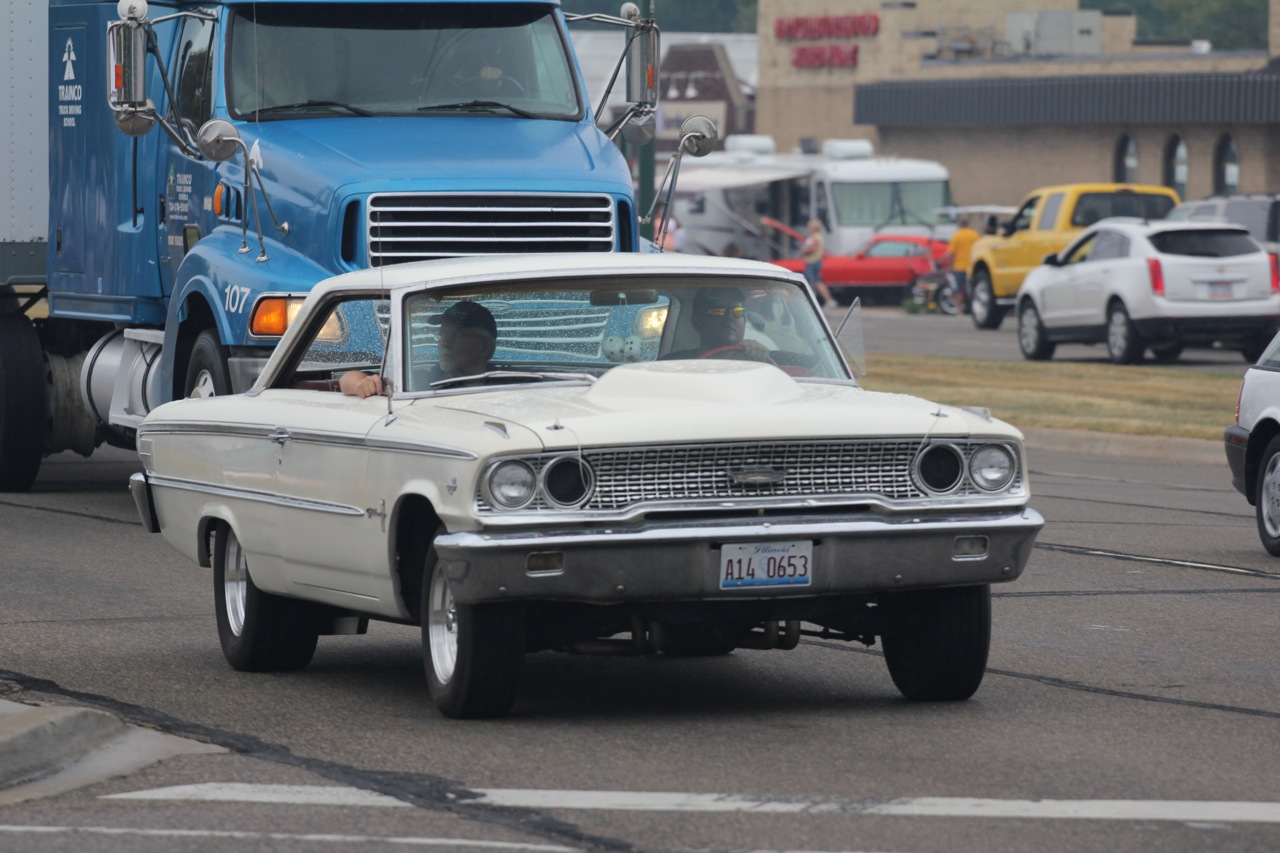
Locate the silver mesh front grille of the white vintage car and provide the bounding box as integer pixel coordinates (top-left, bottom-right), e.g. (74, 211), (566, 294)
(476, 438), (1021, 512)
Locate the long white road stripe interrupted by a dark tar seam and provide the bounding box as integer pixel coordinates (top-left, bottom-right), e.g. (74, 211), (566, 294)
(104, 783), (1280, 824)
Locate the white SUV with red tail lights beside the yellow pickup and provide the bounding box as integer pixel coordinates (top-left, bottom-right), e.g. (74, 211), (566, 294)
(1018, 218), (1280, 364)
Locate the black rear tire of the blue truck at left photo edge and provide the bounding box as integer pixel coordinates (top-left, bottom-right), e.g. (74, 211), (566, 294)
(0, 314), (45, 492)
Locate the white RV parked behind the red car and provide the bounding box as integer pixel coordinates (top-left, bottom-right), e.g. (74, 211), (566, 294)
(673, 134), (955, 260)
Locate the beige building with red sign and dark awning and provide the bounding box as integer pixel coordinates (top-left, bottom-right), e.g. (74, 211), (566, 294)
(754, 0), (1280, 204)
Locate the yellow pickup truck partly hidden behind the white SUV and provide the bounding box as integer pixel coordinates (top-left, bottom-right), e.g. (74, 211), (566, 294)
(969, 183), (1179, 329)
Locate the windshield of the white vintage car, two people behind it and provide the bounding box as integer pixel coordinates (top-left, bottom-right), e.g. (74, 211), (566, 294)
(401, 277), (849, 392)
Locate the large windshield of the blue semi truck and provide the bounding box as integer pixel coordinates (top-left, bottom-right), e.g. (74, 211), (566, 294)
(227, 3), (585, 122)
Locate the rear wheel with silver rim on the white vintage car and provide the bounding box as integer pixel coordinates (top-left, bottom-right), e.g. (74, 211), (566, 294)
(214, 524), (320, 672)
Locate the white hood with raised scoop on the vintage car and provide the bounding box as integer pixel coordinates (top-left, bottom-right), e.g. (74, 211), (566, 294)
(407, 360), (1020, 450)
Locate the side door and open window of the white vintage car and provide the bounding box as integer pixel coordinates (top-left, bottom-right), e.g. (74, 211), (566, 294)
(261, 292), (389, 603)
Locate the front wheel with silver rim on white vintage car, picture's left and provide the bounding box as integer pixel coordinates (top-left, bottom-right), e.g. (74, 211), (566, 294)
(420, 548), (525, 719)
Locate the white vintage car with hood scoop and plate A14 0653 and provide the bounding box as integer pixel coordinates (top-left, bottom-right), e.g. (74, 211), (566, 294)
(131, 249), (1043, 717)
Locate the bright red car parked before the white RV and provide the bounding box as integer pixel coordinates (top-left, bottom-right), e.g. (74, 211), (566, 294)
(772, 234), (947, 305)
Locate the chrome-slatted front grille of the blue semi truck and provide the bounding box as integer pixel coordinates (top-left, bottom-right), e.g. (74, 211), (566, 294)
(367, 193), (616, 266)
